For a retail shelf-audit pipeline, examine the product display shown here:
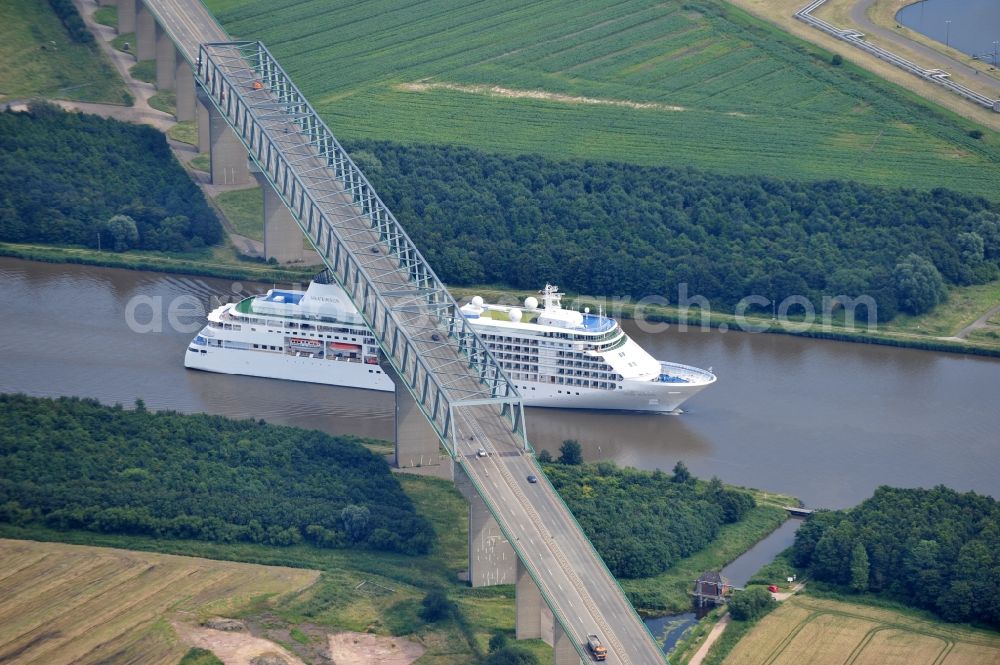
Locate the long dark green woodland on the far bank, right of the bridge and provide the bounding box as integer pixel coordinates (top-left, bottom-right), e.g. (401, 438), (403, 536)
(348, 141), (1000, 320)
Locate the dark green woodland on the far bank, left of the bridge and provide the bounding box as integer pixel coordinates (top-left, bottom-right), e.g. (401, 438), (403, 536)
(0, 103), (222, 251)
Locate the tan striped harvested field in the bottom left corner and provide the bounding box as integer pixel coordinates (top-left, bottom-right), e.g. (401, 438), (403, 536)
(0, 539), (318, 665)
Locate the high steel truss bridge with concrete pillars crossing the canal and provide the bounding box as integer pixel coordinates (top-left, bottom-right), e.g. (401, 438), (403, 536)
(105, 0), (664, 665)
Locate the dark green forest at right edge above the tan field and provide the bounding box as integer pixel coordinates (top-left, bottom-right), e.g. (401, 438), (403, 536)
(792, 486), (1000, 628)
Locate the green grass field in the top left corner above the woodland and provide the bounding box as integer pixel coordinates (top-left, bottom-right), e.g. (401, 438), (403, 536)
(0, 0), (131, 104)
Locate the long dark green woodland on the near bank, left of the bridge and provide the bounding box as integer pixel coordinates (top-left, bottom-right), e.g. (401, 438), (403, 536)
(0, 395), (434, 554)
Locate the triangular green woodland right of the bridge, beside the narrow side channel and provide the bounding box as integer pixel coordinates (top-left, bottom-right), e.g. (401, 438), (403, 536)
(544, 462), (756, 578)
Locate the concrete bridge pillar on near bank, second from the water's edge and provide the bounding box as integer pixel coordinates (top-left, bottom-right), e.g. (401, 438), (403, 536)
(455, 466), (516, 593)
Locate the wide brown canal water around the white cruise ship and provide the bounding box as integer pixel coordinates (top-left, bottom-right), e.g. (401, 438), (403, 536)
(0, 258), (1000, 508)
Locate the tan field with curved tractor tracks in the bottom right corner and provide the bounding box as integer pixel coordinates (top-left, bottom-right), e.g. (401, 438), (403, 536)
(724, 596), (1000, 665)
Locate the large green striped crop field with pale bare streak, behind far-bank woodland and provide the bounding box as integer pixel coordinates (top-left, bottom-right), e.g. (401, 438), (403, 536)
(207, 0), (1000, 198)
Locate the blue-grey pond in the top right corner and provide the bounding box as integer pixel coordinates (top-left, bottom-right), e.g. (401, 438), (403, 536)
(896, 0), (1000, 59)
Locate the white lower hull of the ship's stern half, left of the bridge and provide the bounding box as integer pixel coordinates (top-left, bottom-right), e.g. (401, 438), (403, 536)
(184, 347), (395, 392)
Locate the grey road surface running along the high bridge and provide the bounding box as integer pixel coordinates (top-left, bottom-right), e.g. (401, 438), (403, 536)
(144, 0), (664, 665)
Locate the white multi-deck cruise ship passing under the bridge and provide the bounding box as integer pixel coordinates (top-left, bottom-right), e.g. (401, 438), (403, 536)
(184, 276), (716, 412)
